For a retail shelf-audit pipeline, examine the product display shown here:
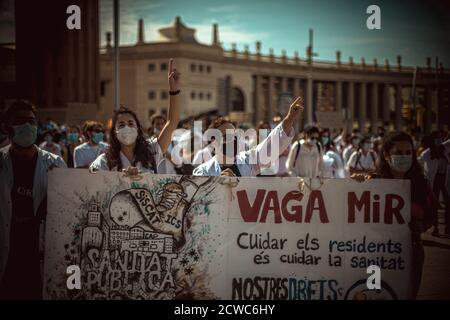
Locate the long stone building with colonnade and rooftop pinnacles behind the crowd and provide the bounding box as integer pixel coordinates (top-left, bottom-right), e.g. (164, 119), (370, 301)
(99, 17), (450, 132)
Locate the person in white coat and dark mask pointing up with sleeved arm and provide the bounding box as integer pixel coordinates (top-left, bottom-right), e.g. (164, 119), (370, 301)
(193, 97), (303, 177)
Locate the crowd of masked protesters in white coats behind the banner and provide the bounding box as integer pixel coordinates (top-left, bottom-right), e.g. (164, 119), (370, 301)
(0, 60), (450, 299)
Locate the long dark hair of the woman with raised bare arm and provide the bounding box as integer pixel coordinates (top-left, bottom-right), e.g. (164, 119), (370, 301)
(106, 106), (157, 173)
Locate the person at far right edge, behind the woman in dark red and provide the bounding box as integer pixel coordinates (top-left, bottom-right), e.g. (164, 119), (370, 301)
(418, 133), (450, 236)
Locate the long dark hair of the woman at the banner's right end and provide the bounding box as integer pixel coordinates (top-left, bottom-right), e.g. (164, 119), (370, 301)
(377, 132), (429, 208)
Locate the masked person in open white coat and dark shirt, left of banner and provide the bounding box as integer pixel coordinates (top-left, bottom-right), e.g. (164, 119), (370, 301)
(0, 100), (66, 299)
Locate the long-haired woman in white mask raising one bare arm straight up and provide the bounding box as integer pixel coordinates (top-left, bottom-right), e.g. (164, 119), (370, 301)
(89, 59), (180, 176)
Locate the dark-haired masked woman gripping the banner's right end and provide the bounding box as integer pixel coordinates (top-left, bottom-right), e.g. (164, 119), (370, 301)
(352, 132), (437, 297)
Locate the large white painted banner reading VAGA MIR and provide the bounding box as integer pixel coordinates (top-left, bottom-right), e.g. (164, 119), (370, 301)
(44, 169), (411, 300)
